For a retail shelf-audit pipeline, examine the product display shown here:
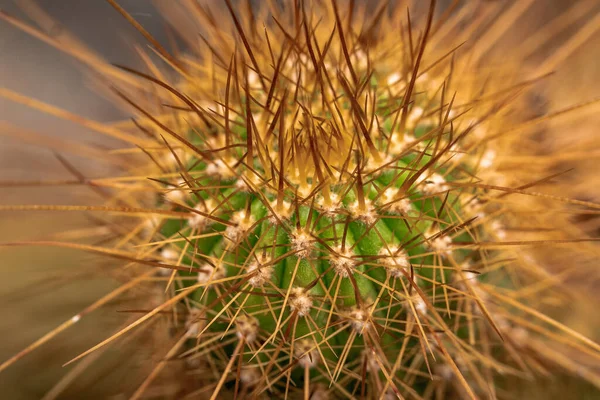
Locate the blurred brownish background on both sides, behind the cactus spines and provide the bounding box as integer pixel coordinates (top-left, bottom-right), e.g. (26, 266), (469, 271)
(0, 0), (600, 400)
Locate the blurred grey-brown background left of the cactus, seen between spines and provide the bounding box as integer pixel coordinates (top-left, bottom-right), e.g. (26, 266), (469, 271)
(0, 0), (170, 400)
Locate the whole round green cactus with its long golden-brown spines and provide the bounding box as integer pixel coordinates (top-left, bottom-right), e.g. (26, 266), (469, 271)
(1, 1), (600, 400)
